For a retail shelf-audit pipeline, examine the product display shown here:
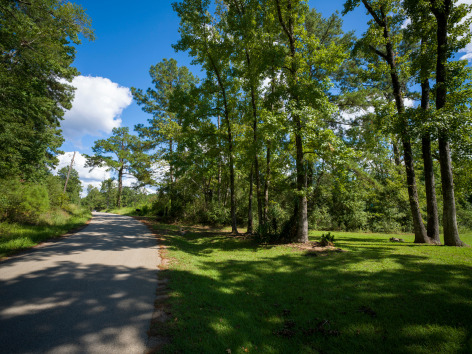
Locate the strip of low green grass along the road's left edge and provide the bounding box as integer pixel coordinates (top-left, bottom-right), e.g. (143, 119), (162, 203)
(0, 208), (91, 258)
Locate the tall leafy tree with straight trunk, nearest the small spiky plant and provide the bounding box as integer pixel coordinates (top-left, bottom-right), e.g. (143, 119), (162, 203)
(271, 0), (345, 242)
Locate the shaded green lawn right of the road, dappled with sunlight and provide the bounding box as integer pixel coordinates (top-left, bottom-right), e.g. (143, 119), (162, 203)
(146, 224), (472, 353)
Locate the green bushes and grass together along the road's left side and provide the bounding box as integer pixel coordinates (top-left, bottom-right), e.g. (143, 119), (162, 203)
(0, 176), (91, 258)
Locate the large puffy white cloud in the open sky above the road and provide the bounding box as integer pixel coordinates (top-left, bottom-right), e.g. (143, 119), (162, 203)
(61, 76), (132, 144)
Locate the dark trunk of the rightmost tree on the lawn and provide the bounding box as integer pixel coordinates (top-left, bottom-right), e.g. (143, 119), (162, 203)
(432, 0), (465, 246)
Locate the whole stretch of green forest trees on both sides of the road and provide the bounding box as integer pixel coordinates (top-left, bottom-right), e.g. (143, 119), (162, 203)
(0, 0), (472, 246)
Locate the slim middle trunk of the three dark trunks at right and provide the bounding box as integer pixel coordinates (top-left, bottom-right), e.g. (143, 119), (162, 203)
(421, 79), (441, 244)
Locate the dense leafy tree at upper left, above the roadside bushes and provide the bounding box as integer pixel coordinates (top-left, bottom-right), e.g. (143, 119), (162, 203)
(0, 0), (93, 179)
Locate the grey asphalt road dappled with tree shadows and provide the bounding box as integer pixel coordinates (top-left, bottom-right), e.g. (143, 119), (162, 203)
(0, 213), (160, 354)
